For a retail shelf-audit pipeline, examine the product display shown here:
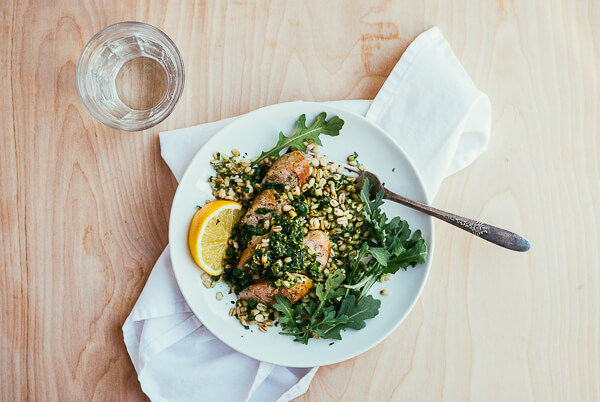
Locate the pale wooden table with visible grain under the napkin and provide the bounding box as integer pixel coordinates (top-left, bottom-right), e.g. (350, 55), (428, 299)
(0, 0), (600, 401)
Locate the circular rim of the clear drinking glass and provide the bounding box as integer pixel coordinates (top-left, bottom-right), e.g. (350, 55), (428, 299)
(75, 21), (185, 132)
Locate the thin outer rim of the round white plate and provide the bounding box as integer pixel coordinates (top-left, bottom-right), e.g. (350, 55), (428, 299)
(168, 101), (435, 368)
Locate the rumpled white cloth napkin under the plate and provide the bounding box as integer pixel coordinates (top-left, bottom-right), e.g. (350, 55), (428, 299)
(123, 28), (491, 401)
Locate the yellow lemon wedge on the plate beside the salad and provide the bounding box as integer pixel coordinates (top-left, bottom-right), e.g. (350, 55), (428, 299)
(188, 200), (242, 276)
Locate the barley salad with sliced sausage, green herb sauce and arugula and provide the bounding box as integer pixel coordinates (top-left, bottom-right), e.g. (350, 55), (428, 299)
(195, 113), (427, 343)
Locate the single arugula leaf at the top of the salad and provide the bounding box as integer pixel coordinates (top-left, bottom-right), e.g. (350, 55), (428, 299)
(252, 112), (344, 166)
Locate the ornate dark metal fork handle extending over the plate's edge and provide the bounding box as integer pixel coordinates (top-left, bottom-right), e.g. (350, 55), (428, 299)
(383, 189), (531, 251)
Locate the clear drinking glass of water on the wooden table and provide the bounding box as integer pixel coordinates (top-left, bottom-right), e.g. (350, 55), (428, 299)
(77, 22), (185, 131)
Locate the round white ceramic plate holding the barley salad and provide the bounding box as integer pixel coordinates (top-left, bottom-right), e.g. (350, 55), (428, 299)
(169, 102), (434, 367)
